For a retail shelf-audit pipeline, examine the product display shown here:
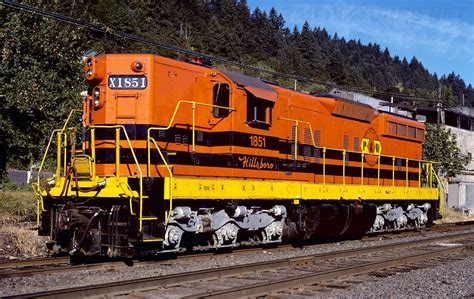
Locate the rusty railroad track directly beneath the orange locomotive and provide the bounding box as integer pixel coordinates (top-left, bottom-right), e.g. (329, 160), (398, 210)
(0, 221), (474, 279)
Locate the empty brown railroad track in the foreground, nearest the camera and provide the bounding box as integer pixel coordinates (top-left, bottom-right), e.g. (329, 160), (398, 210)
(11, 232), (474, 298)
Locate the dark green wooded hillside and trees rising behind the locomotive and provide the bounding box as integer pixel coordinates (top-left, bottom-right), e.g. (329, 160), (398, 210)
(0, 0), (474, 175)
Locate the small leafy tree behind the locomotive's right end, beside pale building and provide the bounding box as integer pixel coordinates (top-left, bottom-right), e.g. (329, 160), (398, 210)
(423, 124), (470, 181)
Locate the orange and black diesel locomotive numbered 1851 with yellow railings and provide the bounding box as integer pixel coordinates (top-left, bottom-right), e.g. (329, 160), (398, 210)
(34, 54), (442, 257)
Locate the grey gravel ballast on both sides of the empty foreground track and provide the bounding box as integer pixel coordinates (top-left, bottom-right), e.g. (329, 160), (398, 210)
(0, 229), (474, 297)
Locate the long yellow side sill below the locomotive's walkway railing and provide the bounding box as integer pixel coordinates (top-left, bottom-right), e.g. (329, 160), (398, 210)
(164, 177), (438, 200)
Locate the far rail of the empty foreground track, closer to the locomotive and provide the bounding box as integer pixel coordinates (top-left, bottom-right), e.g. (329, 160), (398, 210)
(12, 232), (474, 298)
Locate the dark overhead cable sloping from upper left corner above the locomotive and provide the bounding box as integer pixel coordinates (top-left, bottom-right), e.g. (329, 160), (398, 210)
(0, 0), (462, 102)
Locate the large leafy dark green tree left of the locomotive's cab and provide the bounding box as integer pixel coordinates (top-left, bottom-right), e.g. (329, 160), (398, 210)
(0, 11), (85, 175)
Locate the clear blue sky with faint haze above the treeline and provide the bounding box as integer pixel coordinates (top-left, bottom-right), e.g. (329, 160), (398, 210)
(247, 0), (474, 86)
